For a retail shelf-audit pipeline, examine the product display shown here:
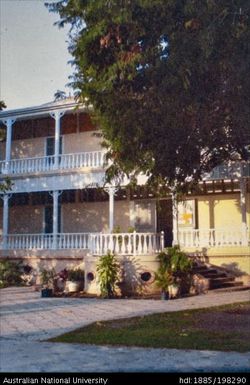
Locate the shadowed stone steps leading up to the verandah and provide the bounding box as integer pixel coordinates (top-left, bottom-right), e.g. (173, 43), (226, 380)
(192, 261), (249, 291)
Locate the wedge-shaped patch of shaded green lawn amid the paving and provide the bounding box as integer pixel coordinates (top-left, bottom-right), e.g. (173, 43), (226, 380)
(49, 302), (250, 352)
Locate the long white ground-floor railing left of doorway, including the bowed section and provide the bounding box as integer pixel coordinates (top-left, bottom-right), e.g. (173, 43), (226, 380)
(1, 232), (164, 255)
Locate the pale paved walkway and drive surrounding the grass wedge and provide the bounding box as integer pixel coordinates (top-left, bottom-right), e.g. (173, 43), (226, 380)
(0, 288), (250, 373)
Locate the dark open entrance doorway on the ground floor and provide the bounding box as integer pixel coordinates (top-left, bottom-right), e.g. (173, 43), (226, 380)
(157, 199), (173, 247)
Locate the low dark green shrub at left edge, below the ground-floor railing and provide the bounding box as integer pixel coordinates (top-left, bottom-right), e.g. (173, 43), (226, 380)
(0, 259), (23, 288)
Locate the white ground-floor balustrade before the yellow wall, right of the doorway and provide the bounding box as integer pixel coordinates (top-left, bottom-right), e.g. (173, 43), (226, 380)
(178, 228), (250, 247)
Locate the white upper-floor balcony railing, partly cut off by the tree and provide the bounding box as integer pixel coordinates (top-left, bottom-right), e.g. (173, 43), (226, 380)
(0, 151), (105, 175)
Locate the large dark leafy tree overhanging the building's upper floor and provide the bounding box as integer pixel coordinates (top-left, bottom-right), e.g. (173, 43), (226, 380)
(48, 0), (250, 190)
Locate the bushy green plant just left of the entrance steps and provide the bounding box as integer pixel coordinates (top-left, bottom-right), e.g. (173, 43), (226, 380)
(155, 246), (192, 291)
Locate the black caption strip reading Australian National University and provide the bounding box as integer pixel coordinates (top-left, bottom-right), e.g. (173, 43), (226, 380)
(0, 368), (250, 385)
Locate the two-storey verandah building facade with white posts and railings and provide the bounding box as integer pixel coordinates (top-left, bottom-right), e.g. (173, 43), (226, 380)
(0, 99), (250, 292)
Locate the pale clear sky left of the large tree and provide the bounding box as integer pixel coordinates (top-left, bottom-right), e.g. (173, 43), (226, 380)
(0, 0), (72, 109)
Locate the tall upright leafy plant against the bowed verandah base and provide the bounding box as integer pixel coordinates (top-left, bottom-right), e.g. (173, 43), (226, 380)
(96, 252), (120, 298)
